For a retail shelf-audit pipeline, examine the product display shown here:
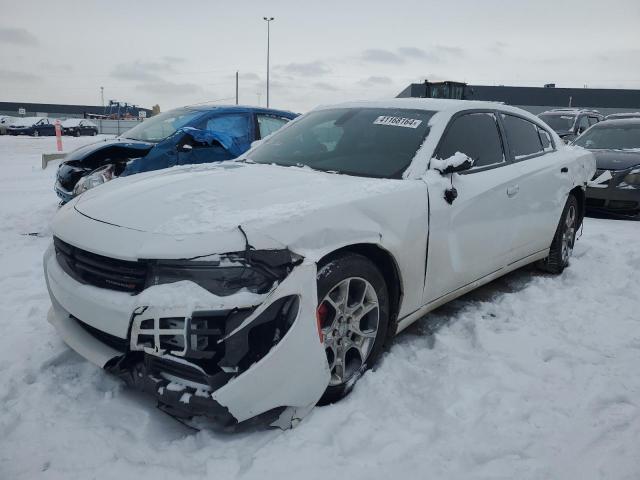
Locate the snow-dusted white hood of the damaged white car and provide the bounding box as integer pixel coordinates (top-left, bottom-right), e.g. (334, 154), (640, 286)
(75, 162), (411, 251)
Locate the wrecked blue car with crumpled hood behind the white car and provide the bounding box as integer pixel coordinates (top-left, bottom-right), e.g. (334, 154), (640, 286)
(55, 106), (298, 203)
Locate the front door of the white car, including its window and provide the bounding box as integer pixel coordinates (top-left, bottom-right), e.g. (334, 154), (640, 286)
(424, 111), (519, 303)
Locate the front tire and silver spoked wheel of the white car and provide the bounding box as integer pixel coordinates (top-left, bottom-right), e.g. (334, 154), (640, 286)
(317, 253), (389, 405)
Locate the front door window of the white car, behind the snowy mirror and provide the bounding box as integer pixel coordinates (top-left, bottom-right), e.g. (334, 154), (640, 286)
(436, 113), (505, 167)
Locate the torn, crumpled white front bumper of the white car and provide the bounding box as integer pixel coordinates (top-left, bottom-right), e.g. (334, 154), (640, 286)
(44, 248), (330, 428)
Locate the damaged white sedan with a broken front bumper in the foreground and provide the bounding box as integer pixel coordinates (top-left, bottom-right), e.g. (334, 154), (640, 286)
(44, 99), (595, 427)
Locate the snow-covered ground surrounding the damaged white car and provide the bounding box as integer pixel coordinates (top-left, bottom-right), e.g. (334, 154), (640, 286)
(0, 137), (640, 480)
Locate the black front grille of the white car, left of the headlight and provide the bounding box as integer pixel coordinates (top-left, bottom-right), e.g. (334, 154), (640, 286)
(53, 237), (147, 293)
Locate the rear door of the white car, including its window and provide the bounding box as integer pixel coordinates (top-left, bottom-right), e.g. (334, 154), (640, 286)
(500, 113), (568, 263)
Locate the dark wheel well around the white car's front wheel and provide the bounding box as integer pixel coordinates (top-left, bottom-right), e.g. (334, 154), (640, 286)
(318, 243), (402, 338)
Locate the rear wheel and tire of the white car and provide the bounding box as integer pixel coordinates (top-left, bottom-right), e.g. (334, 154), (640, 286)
(538, 194), (579, 275)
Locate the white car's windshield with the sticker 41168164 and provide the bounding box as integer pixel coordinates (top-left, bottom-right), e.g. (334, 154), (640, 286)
(251, 108), (435, 178)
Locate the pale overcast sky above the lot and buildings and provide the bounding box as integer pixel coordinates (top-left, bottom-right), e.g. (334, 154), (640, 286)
(0, 0), (640, 112)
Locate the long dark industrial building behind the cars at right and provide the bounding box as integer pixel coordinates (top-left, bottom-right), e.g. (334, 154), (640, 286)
(397, 81), (640, 115)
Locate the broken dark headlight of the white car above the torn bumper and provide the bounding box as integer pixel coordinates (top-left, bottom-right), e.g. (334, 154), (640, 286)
(146, 250), (294, 297)
